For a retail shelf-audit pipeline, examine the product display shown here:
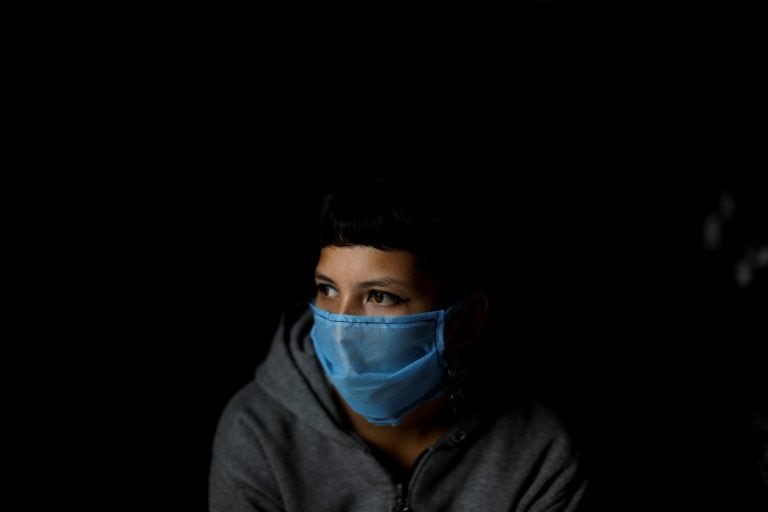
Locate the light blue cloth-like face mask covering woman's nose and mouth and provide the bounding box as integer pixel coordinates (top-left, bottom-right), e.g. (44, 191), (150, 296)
(310, 304), (454, 425)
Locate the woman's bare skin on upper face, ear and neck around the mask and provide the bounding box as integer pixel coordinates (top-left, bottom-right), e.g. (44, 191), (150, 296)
(315, 246), (488, 471)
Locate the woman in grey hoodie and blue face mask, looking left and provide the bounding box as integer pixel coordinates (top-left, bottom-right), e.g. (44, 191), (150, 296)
(210, 181), (585, 512)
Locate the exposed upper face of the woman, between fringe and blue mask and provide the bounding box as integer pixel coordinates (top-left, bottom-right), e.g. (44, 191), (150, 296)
(315, 245), (439, 316)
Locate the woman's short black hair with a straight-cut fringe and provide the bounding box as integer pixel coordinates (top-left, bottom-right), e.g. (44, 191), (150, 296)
(317, 179), (478, 302)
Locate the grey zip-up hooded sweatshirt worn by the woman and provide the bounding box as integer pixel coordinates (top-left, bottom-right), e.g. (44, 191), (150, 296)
(209, 308), (586, 512)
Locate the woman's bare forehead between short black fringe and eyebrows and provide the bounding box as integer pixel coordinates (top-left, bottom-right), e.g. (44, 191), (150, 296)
(317, 245), (428, 286)
